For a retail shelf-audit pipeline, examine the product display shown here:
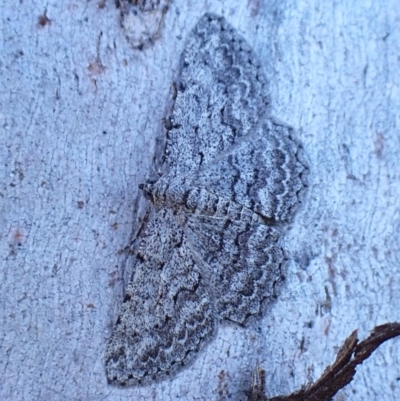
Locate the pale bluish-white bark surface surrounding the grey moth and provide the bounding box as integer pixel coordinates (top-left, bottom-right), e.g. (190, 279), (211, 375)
(0, 0), (400, 401)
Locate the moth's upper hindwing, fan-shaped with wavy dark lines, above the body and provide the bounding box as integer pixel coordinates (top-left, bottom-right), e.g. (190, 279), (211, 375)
(190, 119), (307, 224)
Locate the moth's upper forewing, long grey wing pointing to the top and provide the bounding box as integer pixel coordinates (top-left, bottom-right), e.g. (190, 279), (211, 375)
(166, 14), (269, 173)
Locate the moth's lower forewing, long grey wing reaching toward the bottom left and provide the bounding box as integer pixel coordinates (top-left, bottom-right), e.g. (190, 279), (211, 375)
(106, 210), (215, 385)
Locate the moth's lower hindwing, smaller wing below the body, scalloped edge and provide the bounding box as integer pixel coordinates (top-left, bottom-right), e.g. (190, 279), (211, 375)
(185, 215), (284, 324)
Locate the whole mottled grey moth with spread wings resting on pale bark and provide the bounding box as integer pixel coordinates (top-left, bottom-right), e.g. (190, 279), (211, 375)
(106, 14), (306, 385)
